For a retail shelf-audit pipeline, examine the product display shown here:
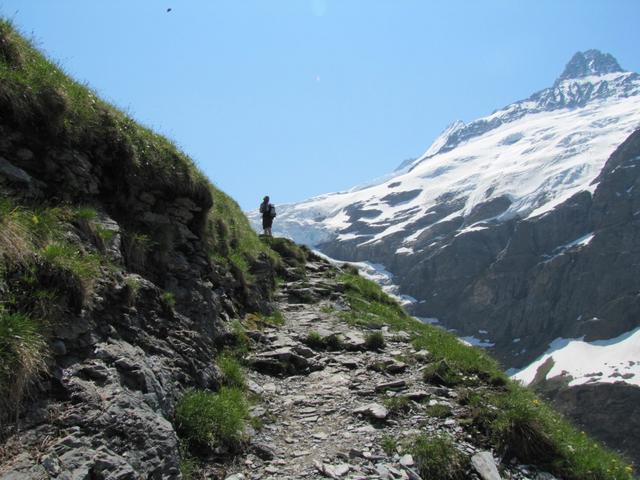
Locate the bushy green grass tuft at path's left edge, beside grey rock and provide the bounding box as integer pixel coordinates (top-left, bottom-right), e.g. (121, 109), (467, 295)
(175, 387), (249, 449)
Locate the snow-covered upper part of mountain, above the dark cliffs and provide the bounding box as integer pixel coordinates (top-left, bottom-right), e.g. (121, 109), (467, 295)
(254, 50), (640, 254)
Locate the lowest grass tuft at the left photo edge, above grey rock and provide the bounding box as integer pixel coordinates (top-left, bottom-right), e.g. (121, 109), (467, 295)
(0, 307), (47, 421)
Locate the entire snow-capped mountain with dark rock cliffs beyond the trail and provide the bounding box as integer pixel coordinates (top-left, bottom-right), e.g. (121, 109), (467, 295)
(260, 50), (640, 464)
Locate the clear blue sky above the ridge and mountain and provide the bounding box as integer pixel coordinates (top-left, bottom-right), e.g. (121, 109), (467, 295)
(0, 0), (640, 209)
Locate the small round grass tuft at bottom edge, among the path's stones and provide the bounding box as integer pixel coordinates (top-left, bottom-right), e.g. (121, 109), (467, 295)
(410, 435), (469, 480)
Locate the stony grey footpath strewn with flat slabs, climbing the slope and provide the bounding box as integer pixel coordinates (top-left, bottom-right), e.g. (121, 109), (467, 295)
(222, 263), (552, 480)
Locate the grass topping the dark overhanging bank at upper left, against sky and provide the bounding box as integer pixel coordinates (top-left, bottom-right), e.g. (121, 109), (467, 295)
(0, 20), (209, 199)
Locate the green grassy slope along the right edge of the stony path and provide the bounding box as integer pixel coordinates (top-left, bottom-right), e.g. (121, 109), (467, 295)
(340, 273), (633, 480)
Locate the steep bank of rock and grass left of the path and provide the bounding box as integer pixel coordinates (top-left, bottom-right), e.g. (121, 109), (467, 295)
(0, 21), (277, 478)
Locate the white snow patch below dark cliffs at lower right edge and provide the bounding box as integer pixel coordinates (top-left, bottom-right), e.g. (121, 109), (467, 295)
(510, 327), (640, 386)
